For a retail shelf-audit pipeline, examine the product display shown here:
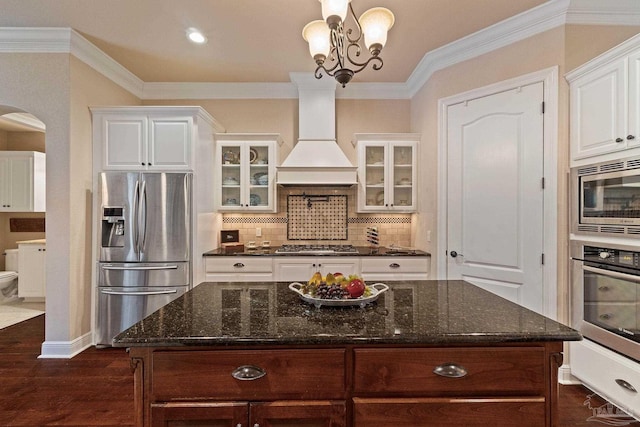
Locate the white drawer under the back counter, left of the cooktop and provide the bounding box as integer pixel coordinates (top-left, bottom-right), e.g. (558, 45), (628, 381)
(204, 256), (274, 282)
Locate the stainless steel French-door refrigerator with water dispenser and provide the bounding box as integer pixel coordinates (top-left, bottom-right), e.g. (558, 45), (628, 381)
(96, 172), (192, 346)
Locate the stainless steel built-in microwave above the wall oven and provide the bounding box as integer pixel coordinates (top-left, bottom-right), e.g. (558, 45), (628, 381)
(571, 158), (640, 238)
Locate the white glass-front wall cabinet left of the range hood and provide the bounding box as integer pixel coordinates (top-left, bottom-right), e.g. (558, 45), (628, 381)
(214, 134), (282, 212)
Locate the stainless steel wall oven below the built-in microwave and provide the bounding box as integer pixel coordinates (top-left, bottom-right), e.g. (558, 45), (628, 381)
(571, 241), (640, 361)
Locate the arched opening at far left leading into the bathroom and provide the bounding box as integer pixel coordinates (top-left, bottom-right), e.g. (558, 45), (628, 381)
(0, 105), (46, 328)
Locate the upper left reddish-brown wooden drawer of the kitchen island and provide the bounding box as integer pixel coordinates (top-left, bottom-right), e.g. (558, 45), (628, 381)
(151, 349), (345, 401)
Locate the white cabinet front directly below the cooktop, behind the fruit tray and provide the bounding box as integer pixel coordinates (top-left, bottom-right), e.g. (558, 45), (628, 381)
(273, 256), (360, 282)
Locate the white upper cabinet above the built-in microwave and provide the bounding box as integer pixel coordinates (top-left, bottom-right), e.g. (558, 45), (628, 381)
(567, 37), (640, 166)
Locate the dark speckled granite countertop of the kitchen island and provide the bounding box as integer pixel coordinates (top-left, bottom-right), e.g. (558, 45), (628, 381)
(114, 280), (581, 347)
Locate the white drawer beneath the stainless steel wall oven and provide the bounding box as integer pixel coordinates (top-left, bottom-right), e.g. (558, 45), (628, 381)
(569, 340), (640, 418)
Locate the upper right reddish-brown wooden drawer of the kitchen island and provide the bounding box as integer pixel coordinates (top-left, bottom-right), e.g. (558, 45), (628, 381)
(354, 347), (545, 396)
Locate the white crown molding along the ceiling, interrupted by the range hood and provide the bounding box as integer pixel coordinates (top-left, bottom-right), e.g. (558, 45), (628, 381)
(0, 0), (640, 100)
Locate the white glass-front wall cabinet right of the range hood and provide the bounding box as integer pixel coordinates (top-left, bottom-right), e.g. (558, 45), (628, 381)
(354, 134), (420, 212)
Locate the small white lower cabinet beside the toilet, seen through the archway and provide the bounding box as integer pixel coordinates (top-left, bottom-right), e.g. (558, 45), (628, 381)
(18, 243), (47, 299)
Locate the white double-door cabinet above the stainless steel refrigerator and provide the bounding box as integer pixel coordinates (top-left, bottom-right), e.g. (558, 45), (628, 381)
(91, 107), (221, 172)
